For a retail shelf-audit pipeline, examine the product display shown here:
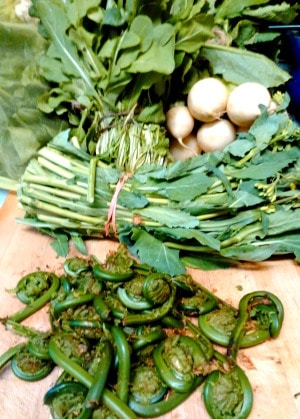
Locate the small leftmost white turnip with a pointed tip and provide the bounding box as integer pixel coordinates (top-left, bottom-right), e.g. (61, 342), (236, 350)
(166, 105), (195, 147)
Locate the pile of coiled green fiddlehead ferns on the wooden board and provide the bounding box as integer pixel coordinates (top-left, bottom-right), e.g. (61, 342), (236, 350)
(0, 246), (284, 419)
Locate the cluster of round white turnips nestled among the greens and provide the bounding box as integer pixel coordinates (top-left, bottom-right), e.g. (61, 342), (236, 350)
(166, 77), (272, 160)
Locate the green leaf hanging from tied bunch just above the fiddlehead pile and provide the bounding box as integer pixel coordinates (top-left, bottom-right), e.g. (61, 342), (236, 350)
(131, 228), (185, 276)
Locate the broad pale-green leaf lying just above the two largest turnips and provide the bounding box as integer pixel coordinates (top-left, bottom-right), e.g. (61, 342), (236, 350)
(201, 44), (291, 88)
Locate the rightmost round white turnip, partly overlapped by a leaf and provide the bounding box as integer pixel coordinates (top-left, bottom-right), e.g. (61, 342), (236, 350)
(226, 82), (271, 127)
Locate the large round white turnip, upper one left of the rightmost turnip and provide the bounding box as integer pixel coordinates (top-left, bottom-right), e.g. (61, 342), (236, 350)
(187, 77), (229, 122)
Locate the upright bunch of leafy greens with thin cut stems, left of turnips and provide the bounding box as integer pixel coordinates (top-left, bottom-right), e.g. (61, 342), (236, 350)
(26, 0), (298, 170)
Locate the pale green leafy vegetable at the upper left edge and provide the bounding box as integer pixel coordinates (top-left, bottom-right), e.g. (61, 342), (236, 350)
(0, 2), (67, 180)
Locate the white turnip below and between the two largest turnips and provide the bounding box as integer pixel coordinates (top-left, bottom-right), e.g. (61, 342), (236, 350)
(197, 119), (236, 152)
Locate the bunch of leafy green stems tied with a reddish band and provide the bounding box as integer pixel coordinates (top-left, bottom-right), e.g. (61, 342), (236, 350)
(14, 101), (300, 275)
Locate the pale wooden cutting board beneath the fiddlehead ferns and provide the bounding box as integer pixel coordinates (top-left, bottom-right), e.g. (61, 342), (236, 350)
(0, 194), (300, 419)
